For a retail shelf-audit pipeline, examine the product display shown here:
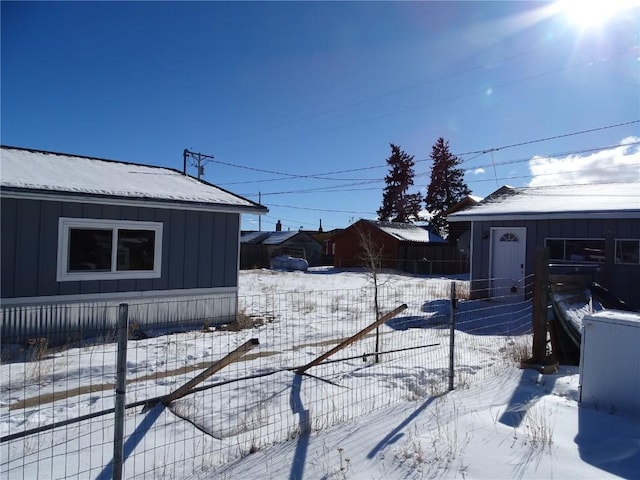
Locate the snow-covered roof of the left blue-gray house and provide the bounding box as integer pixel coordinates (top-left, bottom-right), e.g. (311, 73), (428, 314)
(0, 146), (266, 213)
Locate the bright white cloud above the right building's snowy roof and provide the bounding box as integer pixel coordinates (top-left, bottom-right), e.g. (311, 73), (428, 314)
(529, 137), (640, 187)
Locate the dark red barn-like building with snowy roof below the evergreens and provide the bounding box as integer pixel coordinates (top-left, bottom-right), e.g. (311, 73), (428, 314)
(329, 220), (459, 274)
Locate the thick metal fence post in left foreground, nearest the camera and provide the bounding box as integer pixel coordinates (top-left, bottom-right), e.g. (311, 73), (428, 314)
(113, 303), (129, 480)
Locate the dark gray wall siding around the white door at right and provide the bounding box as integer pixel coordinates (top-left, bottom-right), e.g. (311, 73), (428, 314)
(471, 219), (640, 308)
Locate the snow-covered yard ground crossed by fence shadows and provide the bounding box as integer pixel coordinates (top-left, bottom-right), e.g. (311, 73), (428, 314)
(0, 269), (640, 480)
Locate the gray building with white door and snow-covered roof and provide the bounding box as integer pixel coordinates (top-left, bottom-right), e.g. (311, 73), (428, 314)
(448, 183), (640, 308)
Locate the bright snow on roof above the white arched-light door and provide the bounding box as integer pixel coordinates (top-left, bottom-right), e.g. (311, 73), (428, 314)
(447, 183), (640, 222)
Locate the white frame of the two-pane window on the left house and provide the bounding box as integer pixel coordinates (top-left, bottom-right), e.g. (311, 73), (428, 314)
(57, 217), (162, 282)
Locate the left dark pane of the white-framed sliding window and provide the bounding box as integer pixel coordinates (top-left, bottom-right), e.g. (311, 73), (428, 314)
(68, 228), (113, 272)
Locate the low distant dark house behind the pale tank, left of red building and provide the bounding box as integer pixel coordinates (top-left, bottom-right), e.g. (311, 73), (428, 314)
(240, 231), (322, 269)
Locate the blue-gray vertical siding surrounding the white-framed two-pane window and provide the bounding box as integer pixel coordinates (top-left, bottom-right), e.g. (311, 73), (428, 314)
(0, 198), (240, 299)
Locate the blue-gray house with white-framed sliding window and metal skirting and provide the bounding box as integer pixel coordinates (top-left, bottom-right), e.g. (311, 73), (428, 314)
(0, 146), (267, 344)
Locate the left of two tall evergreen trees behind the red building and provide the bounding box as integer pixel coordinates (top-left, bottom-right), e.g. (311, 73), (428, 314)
(377, 144), (423, 223)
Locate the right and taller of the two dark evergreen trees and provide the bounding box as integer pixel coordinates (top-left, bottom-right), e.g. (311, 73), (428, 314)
(425, 137), (471, 238)
